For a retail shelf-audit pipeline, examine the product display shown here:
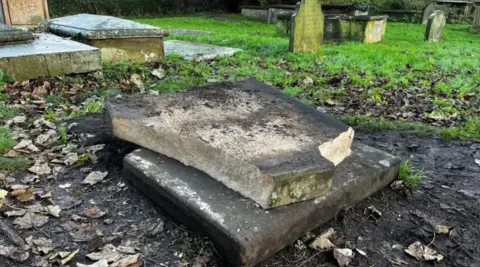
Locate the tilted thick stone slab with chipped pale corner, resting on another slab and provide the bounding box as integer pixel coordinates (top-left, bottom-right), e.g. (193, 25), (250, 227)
(107, 79), (354, 208)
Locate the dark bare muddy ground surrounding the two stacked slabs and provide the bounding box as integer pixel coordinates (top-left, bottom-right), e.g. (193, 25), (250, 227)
(0, 115), (480, 267)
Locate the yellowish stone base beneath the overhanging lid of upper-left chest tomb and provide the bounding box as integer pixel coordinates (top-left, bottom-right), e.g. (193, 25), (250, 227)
(86, 37), (164, 62)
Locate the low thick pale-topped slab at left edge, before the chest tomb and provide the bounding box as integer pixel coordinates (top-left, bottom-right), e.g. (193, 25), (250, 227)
(0, 33), (102, 81)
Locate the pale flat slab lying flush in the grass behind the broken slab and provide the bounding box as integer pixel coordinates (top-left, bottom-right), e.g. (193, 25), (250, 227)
(165, 40), (242, 61)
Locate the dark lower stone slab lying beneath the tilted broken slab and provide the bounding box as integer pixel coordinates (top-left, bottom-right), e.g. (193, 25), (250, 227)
(124, 143), (400, 266)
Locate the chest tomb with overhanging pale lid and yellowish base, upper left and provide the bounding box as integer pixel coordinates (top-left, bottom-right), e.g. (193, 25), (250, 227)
(42, 14), (168, 62)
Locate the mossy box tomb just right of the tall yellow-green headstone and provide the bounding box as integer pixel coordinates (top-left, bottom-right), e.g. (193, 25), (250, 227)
(324, 16), (388, 44)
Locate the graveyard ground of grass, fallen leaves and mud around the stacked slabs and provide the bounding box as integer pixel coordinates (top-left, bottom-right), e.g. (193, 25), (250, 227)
(0, 15), (480, 266)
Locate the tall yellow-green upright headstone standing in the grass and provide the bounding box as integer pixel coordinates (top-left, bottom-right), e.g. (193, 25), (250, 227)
(290, 0), (324, 53)
